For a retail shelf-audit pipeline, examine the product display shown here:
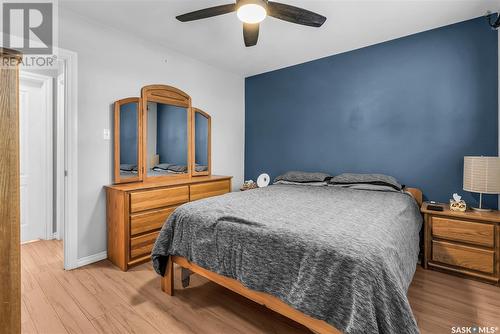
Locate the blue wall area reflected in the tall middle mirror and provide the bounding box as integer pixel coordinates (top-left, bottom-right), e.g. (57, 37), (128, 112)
(156, 103), (188, 165)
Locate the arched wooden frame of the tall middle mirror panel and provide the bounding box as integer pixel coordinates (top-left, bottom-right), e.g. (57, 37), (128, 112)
(140, 85), (193, 181)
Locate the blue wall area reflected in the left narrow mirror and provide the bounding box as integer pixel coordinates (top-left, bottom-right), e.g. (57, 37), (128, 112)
(120, 103), (138, 164)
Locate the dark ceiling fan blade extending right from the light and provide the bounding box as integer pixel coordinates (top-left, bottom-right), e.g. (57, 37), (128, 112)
(267, 1), (326, 27)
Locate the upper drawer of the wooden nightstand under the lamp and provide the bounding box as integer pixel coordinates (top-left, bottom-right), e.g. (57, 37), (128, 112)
(432, 217), (495, 247)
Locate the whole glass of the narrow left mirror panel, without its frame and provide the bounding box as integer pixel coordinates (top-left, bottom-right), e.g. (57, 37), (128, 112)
(120, 102), (139, 178)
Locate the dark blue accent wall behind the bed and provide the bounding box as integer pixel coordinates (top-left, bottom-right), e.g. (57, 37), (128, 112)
(245, 18), (498, 207)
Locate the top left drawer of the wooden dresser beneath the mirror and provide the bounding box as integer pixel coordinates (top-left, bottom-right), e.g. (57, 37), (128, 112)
(130, 186), (189, 212)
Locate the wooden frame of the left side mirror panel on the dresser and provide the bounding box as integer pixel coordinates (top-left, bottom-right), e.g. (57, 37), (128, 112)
(113, 97), (144, 183)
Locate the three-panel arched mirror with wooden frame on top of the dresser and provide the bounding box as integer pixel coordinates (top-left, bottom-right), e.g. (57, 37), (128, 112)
(114, 85), (211, 183)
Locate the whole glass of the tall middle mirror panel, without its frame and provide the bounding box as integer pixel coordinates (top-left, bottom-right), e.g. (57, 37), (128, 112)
(146, 102), (188, 176)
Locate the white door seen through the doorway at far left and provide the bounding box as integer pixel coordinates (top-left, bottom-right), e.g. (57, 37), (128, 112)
(19, 71), (57, 243)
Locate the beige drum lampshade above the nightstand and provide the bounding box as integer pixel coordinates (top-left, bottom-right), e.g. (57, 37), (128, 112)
(464, 157), (500, 194)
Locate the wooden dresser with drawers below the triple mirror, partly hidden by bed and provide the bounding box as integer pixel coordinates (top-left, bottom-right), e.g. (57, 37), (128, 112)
(106, 175), (231, 271)
